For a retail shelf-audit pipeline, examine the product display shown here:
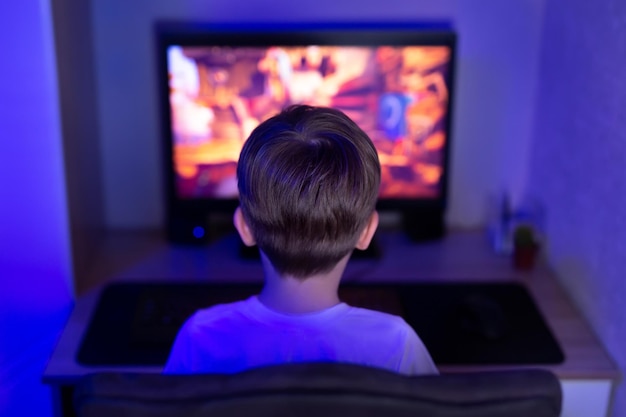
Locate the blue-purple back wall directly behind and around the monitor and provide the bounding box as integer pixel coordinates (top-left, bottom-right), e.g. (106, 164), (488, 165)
(92, 0), (545, 228)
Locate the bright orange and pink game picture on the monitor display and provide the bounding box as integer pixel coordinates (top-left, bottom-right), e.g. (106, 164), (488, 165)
(168, 46), (451, 199)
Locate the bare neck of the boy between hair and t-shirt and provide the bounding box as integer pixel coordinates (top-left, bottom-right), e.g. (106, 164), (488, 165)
(259, 255), (349, 314)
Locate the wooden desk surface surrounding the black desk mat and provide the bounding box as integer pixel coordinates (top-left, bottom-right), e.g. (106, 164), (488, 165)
(43, 232), (620, 385)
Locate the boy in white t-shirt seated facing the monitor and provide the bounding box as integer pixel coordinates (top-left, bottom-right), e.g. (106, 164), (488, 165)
(164, 105), (437, 375)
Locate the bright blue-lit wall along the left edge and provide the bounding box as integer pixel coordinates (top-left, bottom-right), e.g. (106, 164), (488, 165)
(0, 1), (73, 415)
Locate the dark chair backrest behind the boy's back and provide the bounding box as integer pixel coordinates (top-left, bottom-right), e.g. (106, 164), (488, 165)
(74, 363), (561, 417)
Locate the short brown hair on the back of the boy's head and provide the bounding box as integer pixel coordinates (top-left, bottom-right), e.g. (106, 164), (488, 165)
(237, 105), (380, 279)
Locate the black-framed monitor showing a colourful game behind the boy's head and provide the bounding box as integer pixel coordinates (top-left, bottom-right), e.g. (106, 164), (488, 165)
(157, 23), (456, 247)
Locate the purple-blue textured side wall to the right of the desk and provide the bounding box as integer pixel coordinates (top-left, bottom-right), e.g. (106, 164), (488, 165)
(529, 0), (626, 416)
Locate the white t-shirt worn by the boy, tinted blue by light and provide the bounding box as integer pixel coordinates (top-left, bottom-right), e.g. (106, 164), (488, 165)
(163, 296), (438, 375)
